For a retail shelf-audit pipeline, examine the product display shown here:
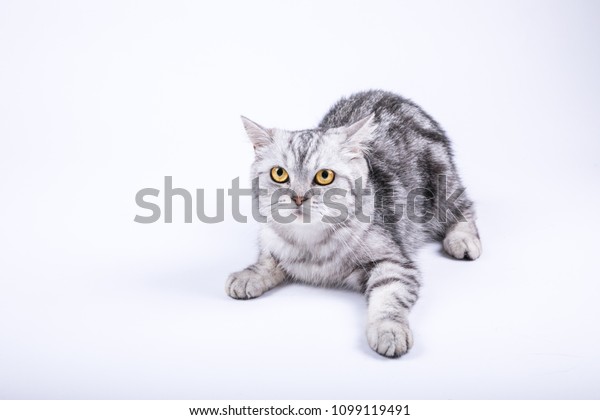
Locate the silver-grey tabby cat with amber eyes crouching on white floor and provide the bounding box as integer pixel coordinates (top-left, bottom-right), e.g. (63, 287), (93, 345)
(226, 90), (482, 357)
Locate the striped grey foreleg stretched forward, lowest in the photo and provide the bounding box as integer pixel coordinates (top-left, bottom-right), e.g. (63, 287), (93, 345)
(365, 260), (420, 357)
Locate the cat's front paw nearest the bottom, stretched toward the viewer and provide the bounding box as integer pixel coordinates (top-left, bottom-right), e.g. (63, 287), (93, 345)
(367, 320), (413, 357)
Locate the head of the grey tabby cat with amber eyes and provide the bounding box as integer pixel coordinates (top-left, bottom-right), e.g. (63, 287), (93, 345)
(242, 115), (374, 243)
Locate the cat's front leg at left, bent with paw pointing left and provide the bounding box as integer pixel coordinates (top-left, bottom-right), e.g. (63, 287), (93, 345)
(225, 254), (285, 299)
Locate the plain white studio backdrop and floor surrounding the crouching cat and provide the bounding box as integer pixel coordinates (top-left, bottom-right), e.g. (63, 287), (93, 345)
(0, 1), (600, 399)
